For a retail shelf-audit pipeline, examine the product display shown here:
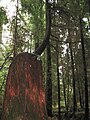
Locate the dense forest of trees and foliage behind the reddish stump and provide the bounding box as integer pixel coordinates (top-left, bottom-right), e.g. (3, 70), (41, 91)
(0, 0), (90, 120)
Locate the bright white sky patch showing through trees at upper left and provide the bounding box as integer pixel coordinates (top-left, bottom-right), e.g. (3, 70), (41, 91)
(0, 0), (16, 44)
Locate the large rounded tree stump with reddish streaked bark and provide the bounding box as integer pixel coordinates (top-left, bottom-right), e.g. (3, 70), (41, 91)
(1, 53), (47, 120)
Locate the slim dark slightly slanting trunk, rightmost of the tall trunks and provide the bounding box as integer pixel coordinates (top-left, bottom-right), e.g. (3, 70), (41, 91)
(79, 16), (89, 120)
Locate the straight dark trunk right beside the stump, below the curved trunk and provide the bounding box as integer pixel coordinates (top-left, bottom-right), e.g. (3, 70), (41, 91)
(46, 42), (52, 117)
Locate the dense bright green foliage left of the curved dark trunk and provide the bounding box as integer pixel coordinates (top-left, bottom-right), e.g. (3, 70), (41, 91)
(21, 0), (45, 42)
